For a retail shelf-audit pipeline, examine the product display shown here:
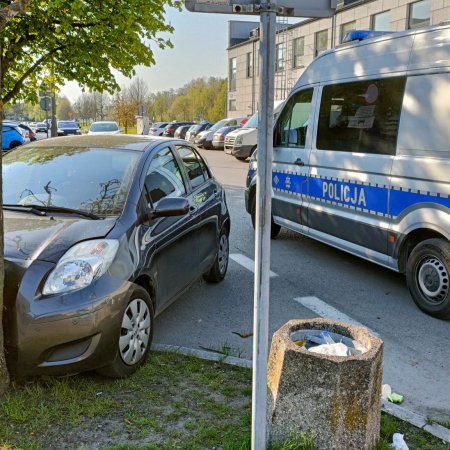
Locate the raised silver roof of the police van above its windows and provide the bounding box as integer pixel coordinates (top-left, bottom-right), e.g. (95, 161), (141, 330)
(294, 24), (450, 89)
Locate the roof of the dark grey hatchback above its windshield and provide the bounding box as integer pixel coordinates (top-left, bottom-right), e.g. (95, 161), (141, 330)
(27, 134), (186, 152)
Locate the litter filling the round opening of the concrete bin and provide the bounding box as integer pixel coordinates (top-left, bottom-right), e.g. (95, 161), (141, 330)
(291, 330), (367, 356)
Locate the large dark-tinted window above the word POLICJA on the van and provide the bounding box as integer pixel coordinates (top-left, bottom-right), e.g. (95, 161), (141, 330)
(317, 77), (406, 155)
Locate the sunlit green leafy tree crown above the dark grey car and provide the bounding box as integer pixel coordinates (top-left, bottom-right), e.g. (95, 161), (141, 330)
(0, 0), (180, 103)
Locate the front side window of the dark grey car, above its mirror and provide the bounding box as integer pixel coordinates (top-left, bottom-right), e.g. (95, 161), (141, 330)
(145, 148), (186, 206)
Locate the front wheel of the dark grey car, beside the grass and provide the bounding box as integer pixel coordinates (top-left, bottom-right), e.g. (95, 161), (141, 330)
(97, 286), (154, 378)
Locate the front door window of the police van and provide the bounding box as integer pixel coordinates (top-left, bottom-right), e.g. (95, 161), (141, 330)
(274, 89), (313, 147)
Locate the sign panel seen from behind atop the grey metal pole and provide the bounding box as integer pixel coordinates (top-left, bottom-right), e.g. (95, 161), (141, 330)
(184, 0), (337, 17)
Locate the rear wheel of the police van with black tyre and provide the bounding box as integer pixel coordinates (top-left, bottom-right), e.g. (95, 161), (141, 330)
(406, 239), (450, 319)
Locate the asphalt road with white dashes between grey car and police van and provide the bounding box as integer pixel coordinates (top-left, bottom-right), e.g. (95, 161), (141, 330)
(154, 150), (450, 420)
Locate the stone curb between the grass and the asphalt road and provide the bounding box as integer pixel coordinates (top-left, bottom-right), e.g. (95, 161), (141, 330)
(152, 344), (450, 442)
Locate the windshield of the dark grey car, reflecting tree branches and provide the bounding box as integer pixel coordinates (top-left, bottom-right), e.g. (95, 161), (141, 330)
(3, 147), (141, 216)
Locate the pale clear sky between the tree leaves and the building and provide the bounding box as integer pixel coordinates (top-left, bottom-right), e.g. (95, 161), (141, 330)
(61, 8), (298, 102)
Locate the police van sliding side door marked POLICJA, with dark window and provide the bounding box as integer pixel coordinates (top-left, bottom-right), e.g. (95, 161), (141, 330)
(308, 76), (405, 264)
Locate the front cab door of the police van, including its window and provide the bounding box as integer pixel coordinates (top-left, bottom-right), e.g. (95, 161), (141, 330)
(272, 87), (317, 231)
